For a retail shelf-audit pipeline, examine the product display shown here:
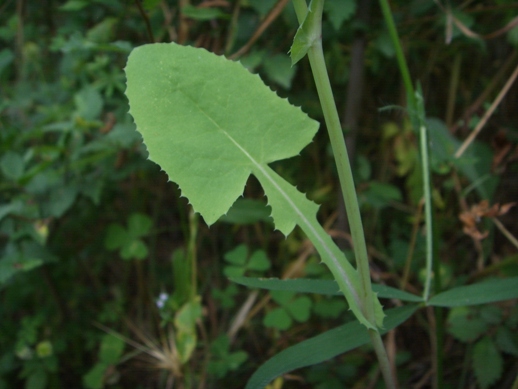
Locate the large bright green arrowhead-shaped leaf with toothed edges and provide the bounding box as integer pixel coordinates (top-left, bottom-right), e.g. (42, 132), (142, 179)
(126, 43), (382, 329)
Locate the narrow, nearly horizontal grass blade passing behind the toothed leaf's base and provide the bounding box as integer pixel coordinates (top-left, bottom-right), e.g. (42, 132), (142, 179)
(229, 277), (423, 302)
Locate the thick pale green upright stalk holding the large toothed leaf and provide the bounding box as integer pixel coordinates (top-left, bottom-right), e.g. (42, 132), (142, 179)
(293, 0), (395, 388)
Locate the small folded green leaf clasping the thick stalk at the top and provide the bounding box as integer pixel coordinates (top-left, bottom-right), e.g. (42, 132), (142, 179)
(290, 0), (324, 66)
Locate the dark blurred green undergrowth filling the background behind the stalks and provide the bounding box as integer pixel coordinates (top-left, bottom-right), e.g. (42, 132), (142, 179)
(0, 0), (518, 389)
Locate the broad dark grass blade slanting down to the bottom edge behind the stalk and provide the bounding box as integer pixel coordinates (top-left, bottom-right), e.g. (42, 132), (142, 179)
(246, 305), (417, 389)
